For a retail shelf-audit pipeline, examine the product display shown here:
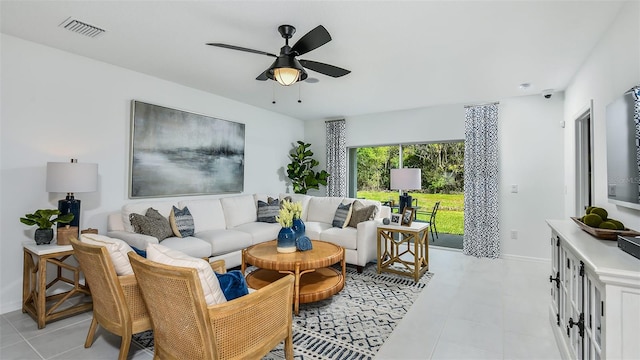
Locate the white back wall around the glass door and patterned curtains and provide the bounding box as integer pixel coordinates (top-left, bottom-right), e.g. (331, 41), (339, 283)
(305, 94), (563, 259)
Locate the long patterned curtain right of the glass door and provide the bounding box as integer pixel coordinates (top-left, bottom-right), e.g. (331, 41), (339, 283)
(462, 104), (500, 259)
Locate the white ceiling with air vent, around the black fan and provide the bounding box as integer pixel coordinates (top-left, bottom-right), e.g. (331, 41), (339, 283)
(0, 0), (621, 120)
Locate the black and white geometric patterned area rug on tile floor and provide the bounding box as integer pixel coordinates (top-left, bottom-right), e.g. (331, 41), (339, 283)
(133, 264), (433, 360)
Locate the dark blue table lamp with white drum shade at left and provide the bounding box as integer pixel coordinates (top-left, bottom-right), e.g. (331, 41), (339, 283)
(47, 159), (98, 229)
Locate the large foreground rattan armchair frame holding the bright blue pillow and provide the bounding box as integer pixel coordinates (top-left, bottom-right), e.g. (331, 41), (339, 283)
(129, 253), (294, 359)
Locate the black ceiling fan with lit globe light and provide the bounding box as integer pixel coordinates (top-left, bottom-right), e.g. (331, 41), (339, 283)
(207, 25), (351, 86)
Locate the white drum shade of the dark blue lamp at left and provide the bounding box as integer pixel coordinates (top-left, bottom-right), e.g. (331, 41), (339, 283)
(47, 162), (98, 193)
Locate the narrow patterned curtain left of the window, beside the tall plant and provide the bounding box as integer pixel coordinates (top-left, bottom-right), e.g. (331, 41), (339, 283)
(326, 119), (347, 197)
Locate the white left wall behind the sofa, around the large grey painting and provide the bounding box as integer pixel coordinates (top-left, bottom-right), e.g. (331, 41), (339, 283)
(0, 35), (304, 313)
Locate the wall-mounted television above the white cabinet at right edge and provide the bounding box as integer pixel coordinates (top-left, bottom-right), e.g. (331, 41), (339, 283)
(606, 86), (640, 210)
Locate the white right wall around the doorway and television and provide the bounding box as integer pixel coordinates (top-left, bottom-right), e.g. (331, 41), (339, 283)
(564, 1), (640, 230)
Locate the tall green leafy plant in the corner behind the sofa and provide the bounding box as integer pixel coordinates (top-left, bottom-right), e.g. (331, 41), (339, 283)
(287, 141), (329, 194)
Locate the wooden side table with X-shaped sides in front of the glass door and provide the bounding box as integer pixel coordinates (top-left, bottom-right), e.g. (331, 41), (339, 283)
(378, 222), (429, 282)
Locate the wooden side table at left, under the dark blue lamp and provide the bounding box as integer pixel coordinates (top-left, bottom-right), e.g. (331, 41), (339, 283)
(22, 241), (93, 329)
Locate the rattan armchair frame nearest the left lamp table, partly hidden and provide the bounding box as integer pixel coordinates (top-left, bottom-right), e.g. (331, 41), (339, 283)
(69, 238), (151, 360)
